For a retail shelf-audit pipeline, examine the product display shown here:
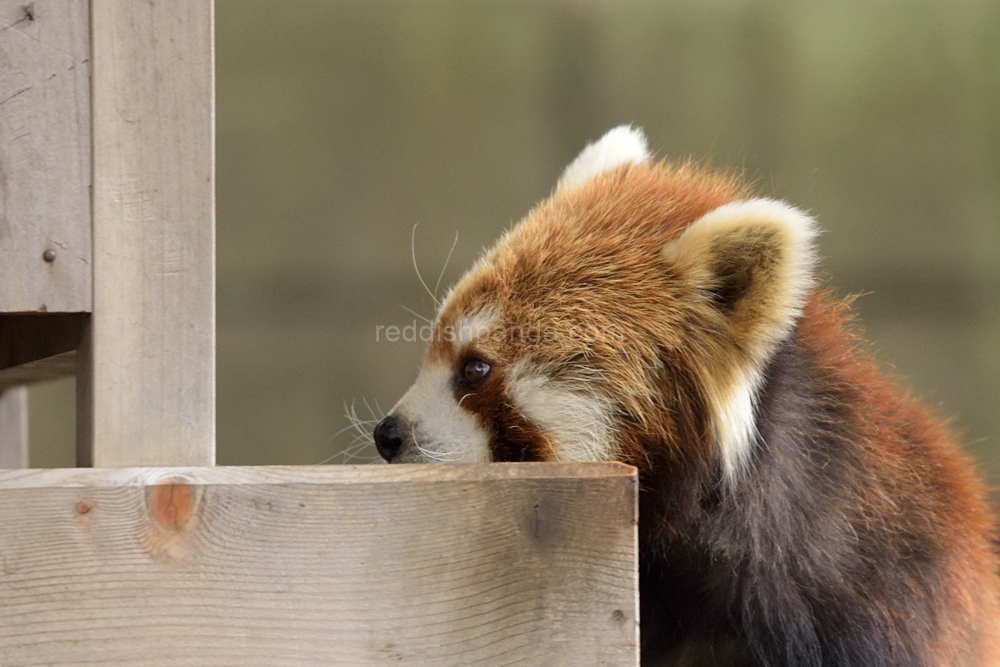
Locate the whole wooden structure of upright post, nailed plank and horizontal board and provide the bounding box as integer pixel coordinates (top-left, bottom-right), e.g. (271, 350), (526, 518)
(0, 0), (638, 667)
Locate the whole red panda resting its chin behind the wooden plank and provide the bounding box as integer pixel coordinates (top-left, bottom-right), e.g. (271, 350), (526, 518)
(374, 126), (1000, 667)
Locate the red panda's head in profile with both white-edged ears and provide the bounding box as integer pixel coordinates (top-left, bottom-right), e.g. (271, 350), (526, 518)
(375, 126), (815, 480)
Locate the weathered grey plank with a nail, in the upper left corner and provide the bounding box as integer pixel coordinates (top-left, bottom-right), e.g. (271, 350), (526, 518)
(0, 0), (91, 312)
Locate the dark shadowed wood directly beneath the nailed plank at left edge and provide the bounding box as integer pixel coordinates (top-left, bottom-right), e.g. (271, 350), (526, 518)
(0, 313), (90, 391)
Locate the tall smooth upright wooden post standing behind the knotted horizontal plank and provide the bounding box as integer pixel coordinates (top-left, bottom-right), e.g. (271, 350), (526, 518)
(83, 0), (215, 466)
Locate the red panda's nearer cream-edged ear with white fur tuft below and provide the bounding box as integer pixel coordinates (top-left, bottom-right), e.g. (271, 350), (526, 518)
(663, 199), (816, 481)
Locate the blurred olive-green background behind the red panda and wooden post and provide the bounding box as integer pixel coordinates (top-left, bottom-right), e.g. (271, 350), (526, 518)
(23, 0), (1000, 490)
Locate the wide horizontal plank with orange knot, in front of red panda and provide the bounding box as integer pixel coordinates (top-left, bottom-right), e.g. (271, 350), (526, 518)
(0, 464), (638, 667)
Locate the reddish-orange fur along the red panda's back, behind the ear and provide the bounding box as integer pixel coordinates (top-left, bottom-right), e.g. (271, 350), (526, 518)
(796, 292), (1000, 666)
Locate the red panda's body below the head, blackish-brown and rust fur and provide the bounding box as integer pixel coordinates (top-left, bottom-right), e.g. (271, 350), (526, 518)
(640, 294), (998, 667)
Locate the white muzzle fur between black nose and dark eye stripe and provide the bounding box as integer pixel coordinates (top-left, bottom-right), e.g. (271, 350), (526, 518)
(392, 364), (490, 463)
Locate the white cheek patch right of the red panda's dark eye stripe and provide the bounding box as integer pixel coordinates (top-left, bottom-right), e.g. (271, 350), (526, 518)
(507, 363), (619, 461)
